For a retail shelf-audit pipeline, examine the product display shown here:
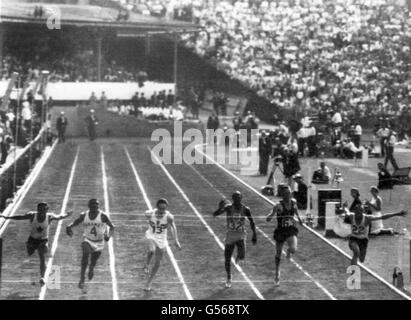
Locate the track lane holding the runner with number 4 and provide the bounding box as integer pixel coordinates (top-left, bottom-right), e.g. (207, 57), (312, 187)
(45, 139), (113, 300)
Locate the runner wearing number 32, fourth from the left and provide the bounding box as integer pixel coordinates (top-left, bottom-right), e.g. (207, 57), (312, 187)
(213, 191), (257, 288)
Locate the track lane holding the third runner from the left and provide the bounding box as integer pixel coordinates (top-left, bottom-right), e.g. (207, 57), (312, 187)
(104, 143), (186, 300)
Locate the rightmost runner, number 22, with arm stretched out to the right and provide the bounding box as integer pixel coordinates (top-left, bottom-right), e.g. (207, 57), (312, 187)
(345, 205), (407, 265)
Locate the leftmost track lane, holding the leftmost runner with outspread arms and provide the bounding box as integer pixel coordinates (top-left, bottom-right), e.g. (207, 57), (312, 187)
(0, 144), (76, 300)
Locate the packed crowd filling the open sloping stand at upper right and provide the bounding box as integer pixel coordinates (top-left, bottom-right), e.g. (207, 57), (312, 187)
(183, 0), (411, 122)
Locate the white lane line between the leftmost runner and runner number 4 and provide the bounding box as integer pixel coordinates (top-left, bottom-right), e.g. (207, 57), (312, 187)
(39, 146), (80, 300)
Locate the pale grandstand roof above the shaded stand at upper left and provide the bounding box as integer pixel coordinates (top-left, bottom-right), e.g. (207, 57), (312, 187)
(0, 1), (199, 33)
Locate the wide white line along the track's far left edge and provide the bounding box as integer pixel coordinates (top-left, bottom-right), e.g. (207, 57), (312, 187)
(0, 140), (57, 237)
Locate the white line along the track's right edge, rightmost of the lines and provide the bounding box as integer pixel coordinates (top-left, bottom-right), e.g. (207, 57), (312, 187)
(195, 145), (411, 300)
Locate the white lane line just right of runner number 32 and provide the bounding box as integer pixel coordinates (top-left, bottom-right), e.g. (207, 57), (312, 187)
(147, 147), (265, 300)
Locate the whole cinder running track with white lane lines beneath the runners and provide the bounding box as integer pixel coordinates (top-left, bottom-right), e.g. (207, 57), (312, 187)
(1, 139), (404, 300)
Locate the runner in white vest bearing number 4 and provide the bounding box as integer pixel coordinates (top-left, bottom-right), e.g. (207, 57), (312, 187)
(66, 199), (114, 292)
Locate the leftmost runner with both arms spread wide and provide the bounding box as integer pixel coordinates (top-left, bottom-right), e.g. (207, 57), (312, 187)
(0, 202), (72, 286)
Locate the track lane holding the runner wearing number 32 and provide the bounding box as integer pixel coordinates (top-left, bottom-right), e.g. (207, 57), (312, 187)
(127, 144), (257, 300)
